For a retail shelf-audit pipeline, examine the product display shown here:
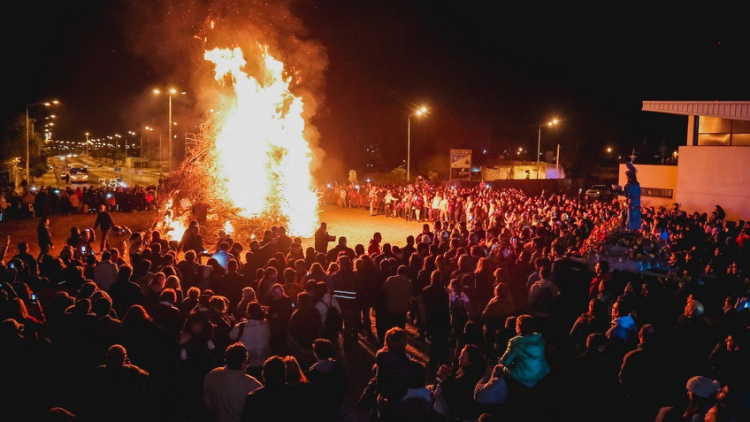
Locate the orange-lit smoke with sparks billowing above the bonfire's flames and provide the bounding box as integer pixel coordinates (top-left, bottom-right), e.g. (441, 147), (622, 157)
(115, 0), (328, 169)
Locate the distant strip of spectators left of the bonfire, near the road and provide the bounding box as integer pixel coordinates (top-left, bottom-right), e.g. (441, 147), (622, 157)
(0, 185), (158, 220)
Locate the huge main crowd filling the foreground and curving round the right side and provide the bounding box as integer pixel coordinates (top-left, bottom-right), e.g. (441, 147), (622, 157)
(0, 180), (750, 421)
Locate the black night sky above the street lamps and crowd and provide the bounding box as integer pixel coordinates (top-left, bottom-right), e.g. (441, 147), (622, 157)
(0, 0), (750, 175)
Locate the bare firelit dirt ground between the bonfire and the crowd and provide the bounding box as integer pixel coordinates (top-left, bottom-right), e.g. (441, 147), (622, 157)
(0, 206), (422, 256)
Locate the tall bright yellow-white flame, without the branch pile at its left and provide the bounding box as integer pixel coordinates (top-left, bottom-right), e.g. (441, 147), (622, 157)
(204, 47), (318, 236)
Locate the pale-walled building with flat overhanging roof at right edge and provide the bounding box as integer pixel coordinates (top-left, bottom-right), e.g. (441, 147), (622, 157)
(620, 101), (750, 220)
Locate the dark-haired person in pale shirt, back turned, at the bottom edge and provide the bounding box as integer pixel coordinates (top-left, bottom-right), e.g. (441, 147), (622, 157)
(203, 343), (262, 422)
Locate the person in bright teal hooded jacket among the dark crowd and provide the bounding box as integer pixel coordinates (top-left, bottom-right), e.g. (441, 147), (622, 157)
(500, 315), (549, 388)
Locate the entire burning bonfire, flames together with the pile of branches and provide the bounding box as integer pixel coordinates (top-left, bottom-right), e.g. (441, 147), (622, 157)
(157, 46), (319, 243)
